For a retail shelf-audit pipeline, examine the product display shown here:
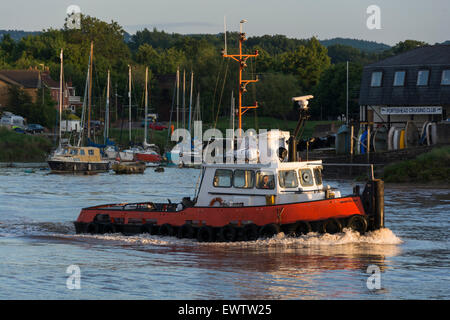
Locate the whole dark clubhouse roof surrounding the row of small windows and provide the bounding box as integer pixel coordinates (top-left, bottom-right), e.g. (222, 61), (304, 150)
(359, 45), (450, 106)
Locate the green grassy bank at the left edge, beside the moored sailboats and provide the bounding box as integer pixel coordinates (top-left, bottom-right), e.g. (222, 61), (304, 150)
(0, 127), (52, 162)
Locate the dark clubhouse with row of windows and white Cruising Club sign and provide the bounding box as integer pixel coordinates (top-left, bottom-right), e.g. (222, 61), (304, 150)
(359, 45), (450, 127)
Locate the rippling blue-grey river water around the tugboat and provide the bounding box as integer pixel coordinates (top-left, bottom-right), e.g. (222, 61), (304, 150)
(0, 167), (450, 299)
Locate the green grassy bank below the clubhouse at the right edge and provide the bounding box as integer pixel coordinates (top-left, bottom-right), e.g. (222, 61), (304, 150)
(384, 147), (450, 183)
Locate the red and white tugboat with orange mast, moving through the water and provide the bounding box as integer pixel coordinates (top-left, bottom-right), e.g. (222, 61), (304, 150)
(74, 20), (384, 242)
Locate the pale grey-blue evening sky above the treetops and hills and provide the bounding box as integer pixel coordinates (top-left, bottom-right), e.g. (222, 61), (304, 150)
(0, 0), (450, 45)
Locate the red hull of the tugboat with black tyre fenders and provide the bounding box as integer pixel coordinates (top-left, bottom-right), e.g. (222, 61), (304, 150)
(75, 190), (380, 241)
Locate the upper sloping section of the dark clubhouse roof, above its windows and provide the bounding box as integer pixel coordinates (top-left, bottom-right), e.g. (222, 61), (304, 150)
(366, 44), (450, 68)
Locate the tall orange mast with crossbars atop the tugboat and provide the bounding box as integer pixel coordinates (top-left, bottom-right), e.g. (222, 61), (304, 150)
(222, 20), (258, 135)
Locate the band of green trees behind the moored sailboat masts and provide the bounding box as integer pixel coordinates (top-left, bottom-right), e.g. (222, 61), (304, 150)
(0, 15), (426, 127)
